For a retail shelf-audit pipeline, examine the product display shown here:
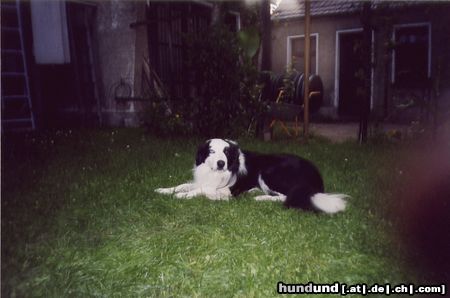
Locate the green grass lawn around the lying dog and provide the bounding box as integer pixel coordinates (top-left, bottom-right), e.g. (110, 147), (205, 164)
(2, 129), (426, 297)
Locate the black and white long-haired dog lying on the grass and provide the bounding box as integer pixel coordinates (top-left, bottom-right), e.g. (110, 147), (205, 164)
(156, 139), (347, 213)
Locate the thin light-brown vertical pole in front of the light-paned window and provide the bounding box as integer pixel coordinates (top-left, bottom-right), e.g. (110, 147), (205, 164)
(303, 0), (311, 140)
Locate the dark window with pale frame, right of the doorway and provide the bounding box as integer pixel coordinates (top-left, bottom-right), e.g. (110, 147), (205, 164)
(392, 24), (431, 87)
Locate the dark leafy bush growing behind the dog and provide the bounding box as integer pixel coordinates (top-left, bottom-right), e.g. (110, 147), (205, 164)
(144, 24), (263, 137)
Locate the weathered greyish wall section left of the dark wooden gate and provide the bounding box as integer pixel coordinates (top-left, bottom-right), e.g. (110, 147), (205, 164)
(94, 0), (138, 126)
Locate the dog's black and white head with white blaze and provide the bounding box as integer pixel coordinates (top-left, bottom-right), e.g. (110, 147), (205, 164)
(195, 139), (245, 173)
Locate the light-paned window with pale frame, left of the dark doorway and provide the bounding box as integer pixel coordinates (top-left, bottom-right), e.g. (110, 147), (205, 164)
(287, 33), (319, 74)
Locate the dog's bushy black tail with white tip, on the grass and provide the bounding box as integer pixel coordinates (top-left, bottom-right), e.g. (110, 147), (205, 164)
(284, 187), (349, 214)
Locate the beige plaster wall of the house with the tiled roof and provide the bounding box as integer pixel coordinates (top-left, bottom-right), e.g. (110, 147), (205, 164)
(272, 3), (450, 118)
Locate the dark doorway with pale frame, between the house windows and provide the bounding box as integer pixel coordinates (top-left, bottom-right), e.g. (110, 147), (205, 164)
(338, 31), (363, 120)
